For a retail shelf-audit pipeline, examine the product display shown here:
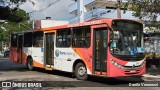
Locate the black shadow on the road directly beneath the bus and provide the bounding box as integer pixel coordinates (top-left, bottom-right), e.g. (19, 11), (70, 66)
(35, 68), (144, 86)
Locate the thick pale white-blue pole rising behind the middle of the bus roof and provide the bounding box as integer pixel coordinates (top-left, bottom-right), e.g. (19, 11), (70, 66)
(75, 0), (84, 22)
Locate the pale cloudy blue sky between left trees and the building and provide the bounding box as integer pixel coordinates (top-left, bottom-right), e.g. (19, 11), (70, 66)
(20, 0), (73, 20)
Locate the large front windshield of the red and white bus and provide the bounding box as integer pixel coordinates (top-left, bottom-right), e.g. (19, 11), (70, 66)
(110, 20), (143, 55)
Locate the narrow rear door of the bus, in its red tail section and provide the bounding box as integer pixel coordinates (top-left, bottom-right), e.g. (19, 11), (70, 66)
(17, 35), (23, 64)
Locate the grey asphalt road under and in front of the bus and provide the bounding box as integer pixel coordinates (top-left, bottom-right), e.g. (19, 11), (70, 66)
(0, 58), (160, 90)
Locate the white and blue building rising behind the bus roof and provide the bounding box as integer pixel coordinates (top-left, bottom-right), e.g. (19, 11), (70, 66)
(68, 0), (138, 23)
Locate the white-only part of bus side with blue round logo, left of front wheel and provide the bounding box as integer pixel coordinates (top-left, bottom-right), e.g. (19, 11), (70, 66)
(54, 48), (75, 72)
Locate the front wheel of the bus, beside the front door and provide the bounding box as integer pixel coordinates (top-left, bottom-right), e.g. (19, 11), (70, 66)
(74, 63), (88, 80)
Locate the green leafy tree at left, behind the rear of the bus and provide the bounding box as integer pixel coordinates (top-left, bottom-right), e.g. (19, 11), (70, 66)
(0, 8), (32, 42)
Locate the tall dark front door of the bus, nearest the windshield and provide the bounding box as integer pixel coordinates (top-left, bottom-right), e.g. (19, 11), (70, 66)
(93, 27), (108, 75)
